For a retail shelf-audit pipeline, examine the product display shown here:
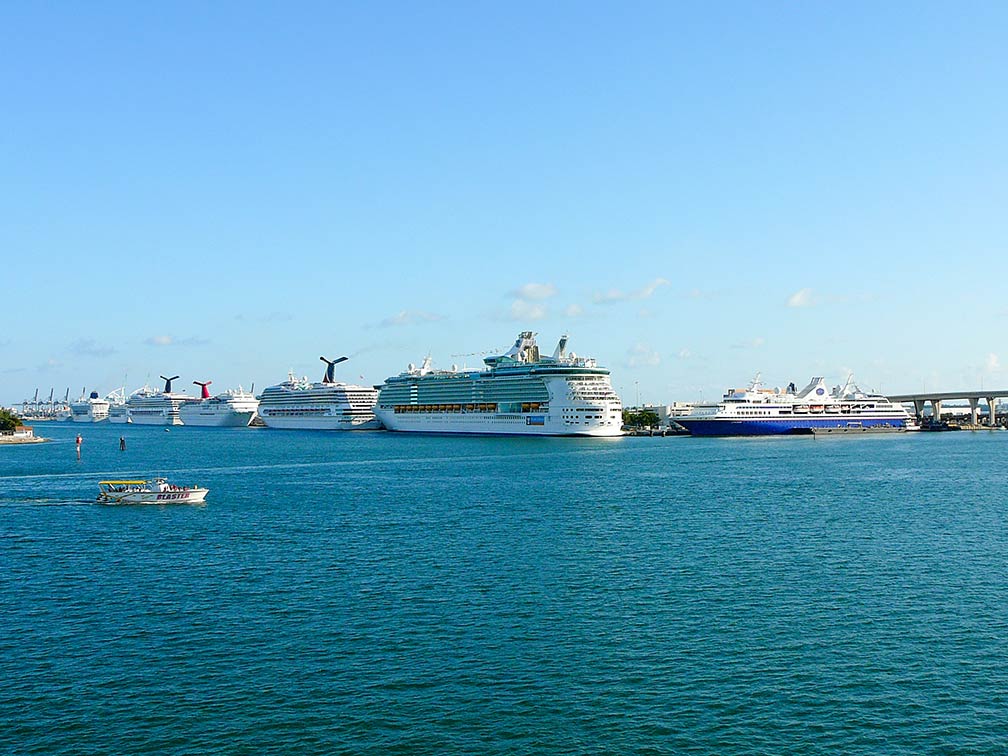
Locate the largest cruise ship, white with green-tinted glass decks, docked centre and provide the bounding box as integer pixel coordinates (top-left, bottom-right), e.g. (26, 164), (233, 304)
(375, 331), (623, 436)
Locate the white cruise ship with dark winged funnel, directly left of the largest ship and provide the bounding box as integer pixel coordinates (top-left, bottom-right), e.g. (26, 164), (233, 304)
(259, 357), (381, 430)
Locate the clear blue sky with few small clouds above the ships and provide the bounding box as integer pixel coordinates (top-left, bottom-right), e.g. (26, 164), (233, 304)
(0, 2), (1008, 405)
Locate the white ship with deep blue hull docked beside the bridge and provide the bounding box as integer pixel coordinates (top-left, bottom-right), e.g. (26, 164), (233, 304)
(675, 374), (915, 435)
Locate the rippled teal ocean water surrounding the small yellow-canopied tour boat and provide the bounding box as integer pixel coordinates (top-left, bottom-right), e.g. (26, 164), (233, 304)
(0, 423), (1008, 755)
